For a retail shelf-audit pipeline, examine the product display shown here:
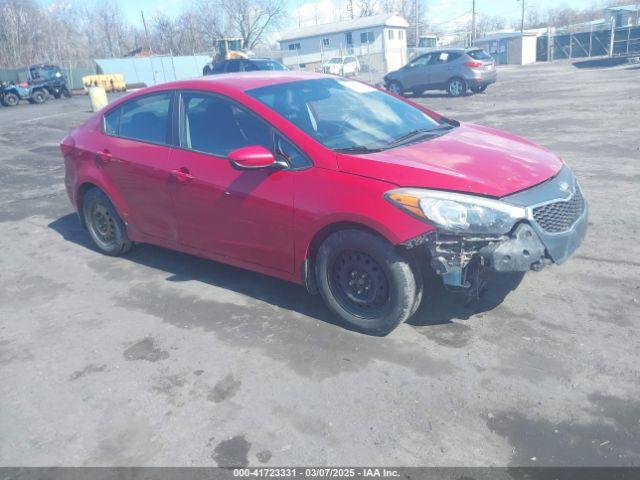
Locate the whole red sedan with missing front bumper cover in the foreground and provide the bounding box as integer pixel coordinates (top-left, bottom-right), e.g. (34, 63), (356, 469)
(61, 72), (587, 334)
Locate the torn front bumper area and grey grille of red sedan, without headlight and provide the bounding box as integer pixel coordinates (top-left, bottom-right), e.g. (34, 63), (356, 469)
(405, 167), (588, 292)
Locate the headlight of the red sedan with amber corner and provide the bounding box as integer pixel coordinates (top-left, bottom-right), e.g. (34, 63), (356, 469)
(385, 188), (527, 234)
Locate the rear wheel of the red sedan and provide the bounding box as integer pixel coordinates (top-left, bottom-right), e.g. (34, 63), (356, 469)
(82, 188), (133, 257)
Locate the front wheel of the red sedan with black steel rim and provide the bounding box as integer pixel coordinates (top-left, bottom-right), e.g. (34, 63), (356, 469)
(315, 230), (422, 335)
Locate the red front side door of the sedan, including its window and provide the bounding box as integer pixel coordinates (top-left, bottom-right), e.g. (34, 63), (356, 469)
(170, 88), (295, 272)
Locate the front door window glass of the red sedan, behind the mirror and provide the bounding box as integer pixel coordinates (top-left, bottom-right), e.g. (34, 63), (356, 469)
(180, 92), (273, 157)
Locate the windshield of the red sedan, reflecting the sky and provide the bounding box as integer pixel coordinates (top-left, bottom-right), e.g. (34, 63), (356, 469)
(246, 78), (452, 152)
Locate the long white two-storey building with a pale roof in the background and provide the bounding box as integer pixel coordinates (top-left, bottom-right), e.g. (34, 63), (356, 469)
(278, 14), (409, 73)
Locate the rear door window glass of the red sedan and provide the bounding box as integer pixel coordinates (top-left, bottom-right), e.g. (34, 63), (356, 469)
(119, 92), (173, 143)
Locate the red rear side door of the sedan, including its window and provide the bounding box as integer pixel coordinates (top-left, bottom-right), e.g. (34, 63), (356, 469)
(96, 91), (176, 240)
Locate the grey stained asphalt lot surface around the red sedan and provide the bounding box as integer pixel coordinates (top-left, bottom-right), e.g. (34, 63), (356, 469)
(0, 58), (640, 466)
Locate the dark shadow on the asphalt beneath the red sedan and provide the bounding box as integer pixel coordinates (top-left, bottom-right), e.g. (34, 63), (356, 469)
(48, 213), (522, 330)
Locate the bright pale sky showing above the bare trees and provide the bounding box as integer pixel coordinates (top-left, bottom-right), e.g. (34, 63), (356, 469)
(41, 0), (600, 30)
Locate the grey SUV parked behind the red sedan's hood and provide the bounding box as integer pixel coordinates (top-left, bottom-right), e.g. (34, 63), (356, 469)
(384, 48), (497, 97)
